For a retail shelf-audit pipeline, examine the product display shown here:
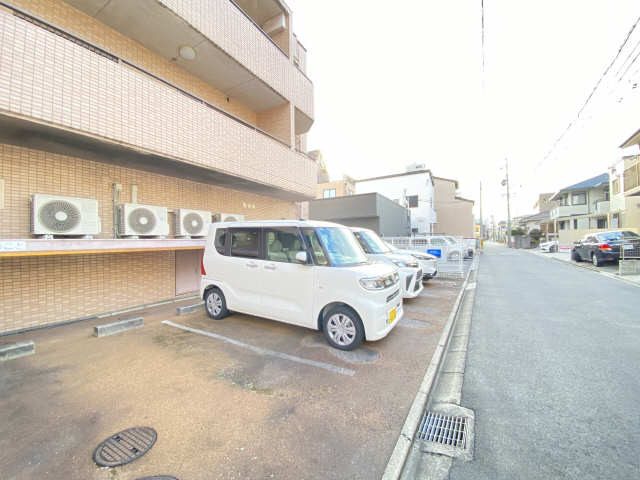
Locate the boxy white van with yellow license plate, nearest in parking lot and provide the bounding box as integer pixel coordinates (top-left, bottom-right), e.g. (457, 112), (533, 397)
(200, 220), (403, 350)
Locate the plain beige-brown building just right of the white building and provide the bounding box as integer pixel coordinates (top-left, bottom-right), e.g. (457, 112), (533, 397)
(433, 177), (475, 238)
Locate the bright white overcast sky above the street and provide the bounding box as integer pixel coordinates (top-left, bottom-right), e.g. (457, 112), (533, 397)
(287, 0), (640, 221)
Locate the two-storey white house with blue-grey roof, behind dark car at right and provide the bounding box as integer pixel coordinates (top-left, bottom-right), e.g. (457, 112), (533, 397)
(549, 173), (618, 245)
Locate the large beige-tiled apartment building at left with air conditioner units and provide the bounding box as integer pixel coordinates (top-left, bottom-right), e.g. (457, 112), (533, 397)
(0, 0), (317, 334)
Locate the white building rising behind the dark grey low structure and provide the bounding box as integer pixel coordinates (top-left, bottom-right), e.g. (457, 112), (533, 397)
(355, 164), (438, 234)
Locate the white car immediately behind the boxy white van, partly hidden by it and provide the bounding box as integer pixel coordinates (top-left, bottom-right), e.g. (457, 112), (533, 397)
(351, 228), (424, 298)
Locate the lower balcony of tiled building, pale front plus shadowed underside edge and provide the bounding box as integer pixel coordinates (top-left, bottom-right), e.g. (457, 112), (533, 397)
(0, 9), (316, 200)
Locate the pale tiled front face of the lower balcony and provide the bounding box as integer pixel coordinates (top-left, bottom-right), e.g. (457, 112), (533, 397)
(0, 9), (316, 197)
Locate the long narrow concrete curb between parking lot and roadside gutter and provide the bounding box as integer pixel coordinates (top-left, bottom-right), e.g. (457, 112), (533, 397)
(382, 260), (479, 480)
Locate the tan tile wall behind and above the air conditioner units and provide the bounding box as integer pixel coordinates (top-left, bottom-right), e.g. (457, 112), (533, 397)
(0, 144), (296, 238)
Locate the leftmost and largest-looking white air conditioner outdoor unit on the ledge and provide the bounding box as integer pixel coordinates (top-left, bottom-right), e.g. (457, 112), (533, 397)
(30, 193), (100, 235)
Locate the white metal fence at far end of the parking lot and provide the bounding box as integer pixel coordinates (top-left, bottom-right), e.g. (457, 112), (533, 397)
(384, 235), (468, 278)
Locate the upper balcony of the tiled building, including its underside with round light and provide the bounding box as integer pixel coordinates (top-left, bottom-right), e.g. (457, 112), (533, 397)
(67, 0), (313, 125)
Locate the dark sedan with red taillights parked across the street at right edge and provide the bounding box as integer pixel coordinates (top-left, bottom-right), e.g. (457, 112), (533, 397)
(571, 230), (640, 267)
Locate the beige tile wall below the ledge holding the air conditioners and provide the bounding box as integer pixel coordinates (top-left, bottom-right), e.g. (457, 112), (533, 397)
(0, 252), (175, 333)
